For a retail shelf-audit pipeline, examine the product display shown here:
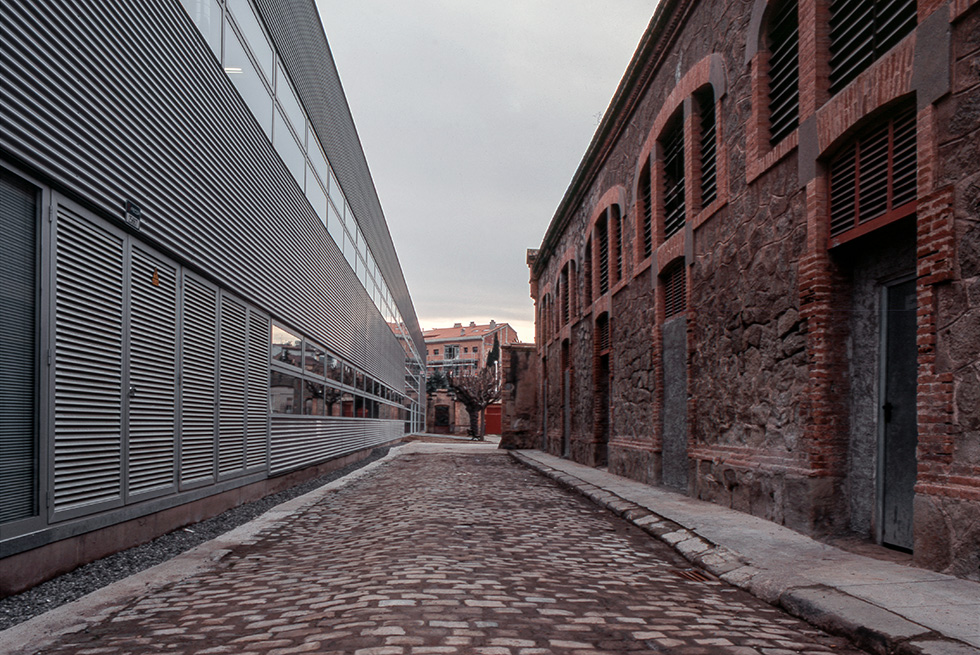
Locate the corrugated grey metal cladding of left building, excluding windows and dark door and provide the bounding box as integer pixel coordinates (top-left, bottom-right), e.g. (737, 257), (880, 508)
(0, 0), (425, 556)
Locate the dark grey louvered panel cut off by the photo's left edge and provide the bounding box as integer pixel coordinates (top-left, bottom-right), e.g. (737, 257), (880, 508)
(0, 176), (37, 523)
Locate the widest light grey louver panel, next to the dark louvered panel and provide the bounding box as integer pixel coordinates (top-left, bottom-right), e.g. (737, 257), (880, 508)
(53, 207), (123, 513)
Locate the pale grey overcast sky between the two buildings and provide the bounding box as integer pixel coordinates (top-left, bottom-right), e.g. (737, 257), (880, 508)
(317, 0), (656, 341)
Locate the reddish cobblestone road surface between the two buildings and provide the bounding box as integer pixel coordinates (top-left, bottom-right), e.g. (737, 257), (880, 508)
(38, 452), (858, 655)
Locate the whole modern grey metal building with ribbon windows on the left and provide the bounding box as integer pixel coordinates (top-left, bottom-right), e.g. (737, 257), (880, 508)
(0, 0), (425, 594)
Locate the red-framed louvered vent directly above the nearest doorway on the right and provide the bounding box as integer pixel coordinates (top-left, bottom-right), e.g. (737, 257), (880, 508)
(830, 107), (917, 236)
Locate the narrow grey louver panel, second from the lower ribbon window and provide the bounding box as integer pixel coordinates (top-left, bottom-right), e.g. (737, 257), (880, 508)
(218, 295), (248, 475)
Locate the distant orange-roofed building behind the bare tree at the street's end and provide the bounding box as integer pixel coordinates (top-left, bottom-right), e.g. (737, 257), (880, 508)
(422, 321), (518, 434)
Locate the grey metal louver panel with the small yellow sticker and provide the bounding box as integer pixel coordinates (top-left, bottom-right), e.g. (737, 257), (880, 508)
(128, 247), (177, 495)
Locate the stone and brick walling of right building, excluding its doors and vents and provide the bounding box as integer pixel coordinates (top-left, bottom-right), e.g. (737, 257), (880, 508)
(534, 0), (980, 578)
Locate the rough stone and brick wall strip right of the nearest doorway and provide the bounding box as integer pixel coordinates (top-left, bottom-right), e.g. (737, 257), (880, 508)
(915, 3), (980, 579)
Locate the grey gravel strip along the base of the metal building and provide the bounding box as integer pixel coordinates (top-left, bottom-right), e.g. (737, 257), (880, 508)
(0, 447), (389, 631)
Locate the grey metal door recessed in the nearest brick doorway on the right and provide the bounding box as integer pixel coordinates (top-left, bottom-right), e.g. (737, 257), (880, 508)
(879, 280), (918, 550)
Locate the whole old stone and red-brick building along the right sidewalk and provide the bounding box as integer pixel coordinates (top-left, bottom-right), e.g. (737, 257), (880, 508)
(528, 0), (980, 578)
